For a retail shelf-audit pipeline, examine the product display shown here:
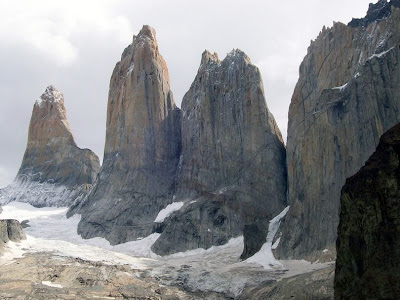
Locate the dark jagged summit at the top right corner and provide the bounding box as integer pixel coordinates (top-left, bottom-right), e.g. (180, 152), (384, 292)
(348, 0), (400, 27)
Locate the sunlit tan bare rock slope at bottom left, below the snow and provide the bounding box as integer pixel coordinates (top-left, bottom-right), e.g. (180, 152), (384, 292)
(0, 253), (227, 300)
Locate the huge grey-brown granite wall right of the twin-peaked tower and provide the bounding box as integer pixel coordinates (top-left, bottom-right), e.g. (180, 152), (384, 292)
(277, 7), (400, 260)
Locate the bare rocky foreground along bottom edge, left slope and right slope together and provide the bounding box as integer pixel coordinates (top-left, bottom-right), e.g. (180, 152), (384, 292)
(0, 252), (334, 300)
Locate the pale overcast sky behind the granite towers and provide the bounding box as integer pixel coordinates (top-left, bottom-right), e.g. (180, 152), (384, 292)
(0, 0), (369, 187)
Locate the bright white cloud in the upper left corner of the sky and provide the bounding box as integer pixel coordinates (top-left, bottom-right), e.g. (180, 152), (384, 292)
(0, 0), (131, 66)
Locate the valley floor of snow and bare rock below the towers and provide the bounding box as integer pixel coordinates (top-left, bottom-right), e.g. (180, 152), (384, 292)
(0, 202), (333, 299)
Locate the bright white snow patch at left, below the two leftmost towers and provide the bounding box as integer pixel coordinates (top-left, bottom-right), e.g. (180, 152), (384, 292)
(0, 202), (160, 267)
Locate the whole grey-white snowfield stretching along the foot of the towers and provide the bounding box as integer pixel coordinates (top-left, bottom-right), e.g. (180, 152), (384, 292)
(0, 202), (327, 297)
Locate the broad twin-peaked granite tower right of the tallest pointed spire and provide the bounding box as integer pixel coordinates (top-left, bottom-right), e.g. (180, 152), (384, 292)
(152, 50), (286, 258)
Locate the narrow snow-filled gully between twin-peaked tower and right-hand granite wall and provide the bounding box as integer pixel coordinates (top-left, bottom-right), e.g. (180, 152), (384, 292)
(245, 206), (289, 270)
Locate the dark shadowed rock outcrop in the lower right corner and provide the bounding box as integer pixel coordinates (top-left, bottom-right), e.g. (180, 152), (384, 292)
(335, 124), (400, 299)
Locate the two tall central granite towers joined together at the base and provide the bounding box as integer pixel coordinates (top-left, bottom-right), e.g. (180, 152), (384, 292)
(76, 26), (286, 258)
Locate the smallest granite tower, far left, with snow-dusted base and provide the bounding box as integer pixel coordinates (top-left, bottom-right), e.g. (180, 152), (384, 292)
(0, 86), (100, 207)
